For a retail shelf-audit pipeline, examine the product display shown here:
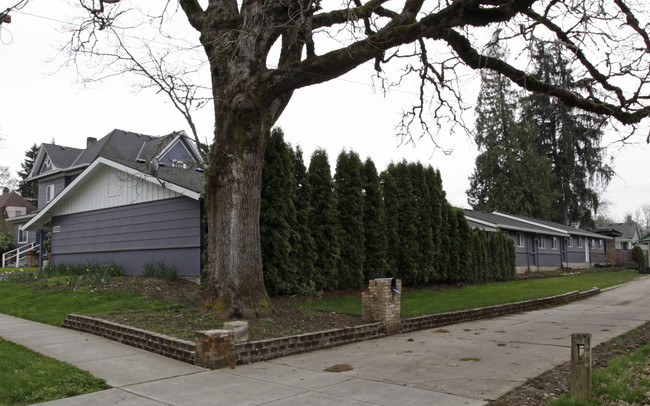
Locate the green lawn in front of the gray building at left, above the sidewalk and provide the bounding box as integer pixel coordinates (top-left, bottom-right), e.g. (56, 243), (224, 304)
(0, 282), (179, 326)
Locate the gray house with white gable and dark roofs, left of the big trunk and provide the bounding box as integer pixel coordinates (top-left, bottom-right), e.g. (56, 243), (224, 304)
(22, 130), (204, 276)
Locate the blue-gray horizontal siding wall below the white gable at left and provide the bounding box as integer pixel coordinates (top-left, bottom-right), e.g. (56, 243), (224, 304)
(52, 197), (201, 276)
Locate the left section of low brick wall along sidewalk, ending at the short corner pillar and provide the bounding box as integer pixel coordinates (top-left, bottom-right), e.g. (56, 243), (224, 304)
(63, 314), (196, 364)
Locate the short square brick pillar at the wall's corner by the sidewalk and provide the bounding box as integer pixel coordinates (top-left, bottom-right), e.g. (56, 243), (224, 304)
(195, 330), (235, 369)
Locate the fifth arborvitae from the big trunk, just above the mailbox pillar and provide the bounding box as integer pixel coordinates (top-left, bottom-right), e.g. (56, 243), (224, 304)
(361, 158), (389, 281)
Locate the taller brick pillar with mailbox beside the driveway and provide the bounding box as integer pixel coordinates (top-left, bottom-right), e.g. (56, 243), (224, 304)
(361, 278), (402, 335)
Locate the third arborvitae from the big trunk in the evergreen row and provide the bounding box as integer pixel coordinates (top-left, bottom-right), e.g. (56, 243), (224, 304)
(307, 149), (341, 289)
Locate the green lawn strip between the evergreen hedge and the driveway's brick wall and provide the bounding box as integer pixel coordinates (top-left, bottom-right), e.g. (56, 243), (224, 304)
(306, 271), (639, 317)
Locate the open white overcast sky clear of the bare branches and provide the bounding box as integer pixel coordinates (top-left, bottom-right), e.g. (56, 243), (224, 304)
(0, 0), (650, 220)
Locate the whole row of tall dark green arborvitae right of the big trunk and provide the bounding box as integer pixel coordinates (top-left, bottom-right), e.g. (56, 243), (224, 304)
(260, 131), (515, 294)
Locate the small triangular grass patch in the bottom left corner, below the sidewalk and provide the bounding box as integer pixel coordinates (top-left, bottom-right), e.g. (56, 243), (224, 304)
(0, 338), (109, 405)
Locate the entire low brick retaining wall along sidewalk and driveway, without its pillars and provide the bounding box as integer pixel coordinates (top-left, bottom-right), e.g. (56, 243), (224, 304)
(63, 288), (600, 364)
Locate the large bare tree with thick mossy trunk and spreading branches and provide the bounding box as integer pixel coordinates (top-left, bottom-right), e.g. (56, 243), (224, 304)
(67, 0), (650, 317)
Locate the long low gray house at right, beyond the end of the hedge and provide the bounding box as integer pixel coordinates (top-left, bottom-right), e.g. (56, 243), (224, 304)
(465, 210), (610, 272)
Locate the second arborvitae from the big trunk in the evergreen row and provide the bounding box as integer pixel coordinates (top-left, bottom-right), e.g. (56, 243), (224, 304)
(290, 146), (316, 286)
